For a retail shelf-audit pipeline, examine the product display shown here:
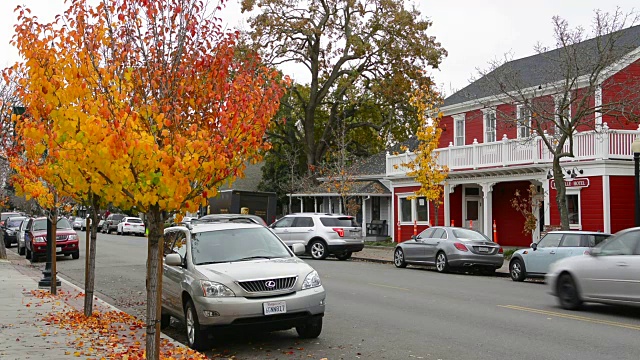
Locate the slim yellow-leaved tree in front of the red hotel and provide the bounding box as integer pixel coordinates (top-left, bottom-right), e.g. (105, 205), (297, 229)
(402, 86), (449, 225)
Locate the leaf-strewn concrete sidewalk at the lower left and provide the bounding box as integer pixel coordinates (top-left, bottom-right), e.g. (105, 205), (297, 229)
(0, 259), (206, 360)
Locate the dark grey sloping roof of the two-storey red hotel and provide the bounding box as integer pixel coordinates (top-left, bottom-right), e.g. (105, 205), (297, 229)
(444, 25), (640, 107)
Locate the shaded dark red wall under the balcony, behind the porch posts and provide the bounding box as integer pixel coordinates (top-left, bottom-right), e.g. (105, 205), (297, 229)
(492, 181), (531, 246)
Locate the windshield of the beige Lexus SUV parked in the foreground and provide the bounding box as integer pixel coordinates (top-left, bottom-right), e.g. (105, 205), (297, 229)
(191, 227), (292, 265)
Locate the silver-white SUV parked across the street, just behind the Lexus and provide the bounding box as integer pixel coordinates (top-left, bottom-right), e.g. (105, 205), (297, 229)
(271, 213), (364, 260)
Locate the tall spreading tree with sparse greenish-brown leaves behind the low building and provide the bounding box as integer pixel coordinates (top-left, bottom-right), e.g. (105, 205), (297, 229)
(242, 0), (446, 172)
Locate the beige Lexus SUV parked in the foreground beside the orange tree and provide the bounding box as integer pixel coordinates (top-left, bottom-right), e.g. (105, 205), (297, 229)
(161, 222), (325, 349)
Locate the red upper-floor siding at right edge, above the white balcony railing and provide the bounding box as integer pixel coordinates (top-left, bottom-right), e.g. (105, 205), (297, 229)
(602, 60), (640, 130)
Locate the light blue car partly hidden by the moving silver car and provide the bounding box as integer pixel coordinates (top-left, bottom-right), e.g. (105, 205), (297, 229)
(509, 231), (611, 281)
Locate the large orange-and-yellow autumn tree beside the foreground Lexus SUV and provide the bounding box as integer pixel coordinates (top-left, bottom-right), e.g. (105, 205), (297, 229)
(9, 0), (286, 359)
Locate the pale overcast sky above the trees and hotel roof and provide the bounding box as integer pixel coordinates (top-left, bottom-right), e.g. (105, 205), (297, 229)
(0, 0), (640, 95)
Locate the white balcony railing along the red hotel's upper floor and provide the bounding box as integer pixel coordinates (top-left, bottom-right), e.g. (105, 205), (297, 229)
(387, 128), (640, 176)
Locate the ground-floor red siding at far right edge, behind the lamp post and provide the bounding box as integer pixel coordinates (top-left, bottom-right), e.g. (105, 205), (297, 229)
(609, 176), (635, 233)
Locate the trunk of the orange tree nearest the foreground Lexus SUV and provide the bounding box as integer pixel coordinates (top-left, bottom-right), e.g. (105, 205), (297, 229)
(146, 205), (164, 360)
